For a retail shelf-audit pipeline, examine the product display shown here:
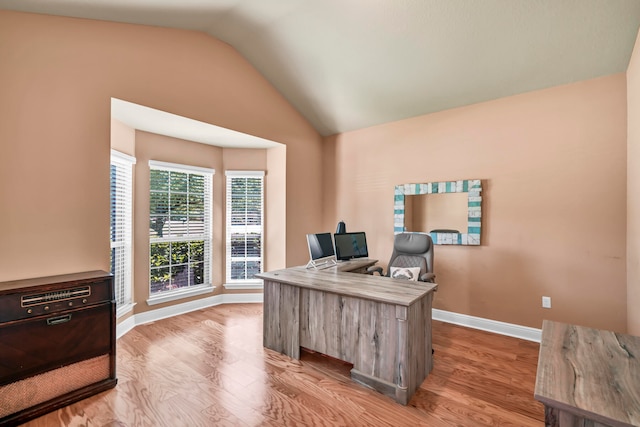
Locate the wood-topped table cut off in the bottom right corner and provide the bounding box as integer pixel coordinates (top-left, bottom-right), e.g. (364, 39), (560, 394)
(534, 320), (640, 427)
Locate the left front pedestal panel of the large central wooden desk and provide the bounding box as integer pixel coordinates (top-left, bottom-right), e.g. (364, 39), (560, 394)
(262, 280), (300, 359)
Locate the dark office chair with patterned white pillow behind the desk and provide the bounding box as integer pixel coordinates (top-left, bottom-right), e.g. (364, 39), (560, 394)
(367, 233), (436, 283)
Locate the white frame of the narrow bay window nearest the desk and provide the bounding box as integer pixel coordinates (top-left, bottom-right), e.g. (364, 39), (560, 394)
(224, 170), (265, 289)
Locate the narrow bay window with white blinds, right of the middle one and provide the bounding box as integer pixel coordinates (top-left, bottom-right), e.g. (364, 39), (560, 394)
(226, 171), (264, 284)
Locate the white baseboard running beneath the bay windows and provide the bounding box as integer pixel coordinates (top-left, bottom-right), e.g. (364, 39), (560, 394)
(116, 293), (263, 338)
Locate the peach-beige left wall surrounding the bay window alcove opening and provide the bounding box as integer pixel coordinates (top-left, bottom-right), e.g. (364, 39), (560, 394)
(0, 11), (322, 281)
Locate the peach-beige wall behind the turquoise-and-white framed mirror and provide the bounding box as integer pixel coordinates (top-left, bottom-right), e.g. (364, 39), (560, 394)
(323, 74), (627, 331)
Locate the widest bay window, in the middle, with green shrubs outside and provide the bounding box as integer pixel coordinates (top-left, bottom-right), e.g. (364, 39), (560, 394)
(149, 161), (215, 299)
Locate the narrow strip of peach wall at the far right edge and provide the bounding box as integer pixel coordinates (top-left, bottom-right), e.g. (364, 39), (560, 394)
(627, 30), (640, 336)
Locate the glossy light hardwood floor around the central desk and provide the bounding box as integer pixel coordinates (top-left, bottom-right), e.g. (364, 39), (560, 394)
(20, 304), (544, 427)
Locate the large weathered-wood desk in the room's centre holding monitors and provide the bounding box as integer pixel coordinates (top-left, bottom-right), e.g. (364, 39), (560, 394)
(258, 263), (437, 405)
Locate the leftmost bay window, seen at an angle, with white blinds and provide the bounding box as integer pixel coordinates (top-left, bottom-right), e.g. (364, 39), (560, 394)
(110, 150), (136, 316)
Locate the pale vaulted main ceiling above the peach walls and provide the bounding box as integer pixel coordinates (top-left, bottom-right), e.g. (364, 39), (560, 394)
(0, 0), (640, 135)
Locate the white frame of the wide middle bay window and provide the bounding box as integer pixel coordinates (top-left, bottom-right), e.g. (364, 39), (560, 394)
(147, 160), (215, 305)
